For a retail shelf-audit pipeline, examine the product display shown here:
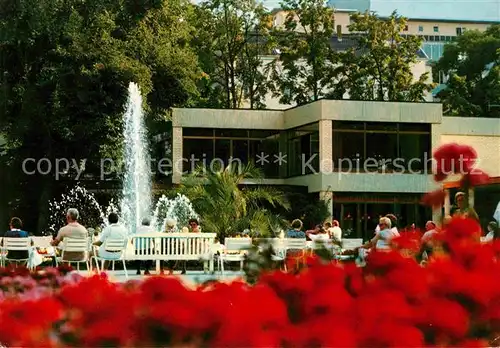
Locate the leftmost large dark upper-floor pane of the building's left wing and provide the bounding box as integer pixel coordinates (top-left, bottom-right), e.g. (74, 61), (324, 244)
(182, 139), (214, 173)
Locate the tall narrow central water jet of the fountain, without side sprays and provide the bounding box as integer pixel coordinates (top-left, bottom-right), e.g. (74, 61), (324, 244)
(120, 82), (151, 233)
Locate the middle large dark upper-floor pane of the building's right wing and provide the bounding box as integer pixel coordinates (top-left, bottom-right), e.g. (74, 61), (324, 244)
(363, 133), (398, 172)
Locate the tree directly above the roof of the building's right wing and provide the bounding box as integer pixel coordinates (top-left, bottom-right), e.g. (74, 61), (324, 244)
(336, 12), (432, 102)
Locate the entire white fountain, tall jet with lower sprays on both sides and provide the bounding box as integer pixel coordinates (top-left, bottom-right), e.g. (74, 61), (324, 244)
(48, 83), (198, 233)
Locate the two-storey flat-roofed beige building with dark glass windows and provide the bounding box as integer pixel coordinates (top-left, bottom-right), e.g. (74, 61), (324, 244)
(172, 100), (500, 238)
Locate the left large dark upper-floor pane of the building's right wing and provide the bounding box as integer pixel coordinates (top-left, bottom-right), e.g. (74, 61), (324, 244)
(333, 132), (365, 171)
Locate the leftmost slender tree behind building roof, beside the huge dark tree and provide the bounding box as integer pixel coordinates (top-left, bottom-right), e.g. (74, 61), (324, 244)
(191, 0), (269, 109)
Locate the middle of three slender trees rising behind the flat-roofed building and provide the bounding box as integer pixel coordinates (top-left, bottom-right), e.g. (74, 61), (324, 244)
(269, 0), (335, 105)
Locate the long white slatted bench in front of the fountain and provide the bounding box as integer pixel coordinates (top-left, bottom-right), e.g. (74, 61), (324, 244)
(126, 233), (217, 272)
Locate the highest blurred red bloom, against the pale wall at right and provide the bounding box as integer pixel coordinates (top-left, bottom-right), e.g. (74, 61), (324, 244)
(433, 143), (477, 180)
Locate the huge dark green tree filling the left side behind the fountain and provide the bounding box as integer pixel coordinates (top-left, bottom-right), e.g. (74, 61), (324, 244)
(0, 0), (203, 231)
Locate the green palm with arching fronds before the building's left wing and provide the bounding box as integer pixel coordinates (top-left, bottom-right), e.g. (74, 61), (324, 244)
(179, 164), (290, 239)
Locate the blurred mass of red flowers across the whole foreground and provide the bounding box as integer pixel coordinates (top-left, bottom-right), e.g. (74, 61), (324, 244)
(0, 218), (500, 347)
